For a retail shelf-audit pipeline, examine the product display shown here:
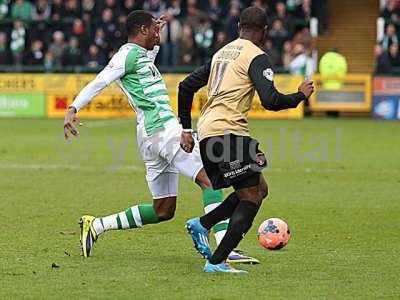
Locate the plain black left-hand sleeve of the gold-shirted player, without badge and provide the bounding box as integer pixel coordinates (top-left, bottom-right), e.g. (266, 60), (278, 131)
(178, 61), (211, 129)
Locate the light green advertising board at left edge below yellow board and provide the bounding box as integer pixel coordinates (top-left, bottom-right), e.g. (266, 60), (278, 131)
(0, 93), (46, 117)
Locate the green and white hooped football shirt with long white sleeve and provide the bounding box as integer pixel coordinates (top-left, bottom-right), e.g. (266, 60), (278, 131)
(71, 43), (176, 136)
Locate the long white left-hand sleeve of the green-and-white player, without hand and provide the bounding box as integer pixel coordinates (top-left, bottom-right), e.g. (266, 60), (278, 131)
(70, 53), (125, 112)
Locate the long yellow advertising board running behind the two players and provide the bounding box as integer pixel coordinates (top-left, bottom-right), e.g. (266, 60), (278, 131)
(0, 73), (303, 119)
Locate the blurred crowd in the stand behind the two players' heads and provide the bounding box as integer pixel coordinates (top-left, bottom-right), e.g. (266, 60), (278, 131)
(0, 0), (316, 73)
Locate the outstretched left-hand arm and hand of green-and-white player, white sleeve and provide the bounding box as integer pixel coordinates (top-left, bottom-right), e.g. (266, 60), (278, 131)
(64, 56), (125, 139)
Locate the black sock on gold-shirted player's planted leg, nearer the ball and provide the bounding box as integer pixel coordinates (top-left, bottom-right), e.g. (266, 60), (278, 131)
(210, 201), (259, 264)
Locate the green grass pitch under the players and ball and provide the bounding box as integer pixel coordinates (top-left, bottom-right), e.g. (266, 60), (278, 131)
(0, 119), (400, 299)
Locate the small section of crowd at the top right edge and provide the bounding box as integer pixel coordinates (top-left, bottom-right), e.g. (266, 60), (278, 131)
(374, 0), (400, 74)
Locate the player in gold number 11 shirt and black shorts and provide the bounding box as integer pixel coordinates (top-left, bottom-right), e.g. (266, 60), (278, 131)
(178, 7), (314, 273)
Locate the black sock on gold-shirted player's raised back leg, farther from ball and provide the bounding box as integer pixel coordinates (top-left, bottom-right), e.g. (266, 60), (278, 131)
(200, 192), (239, 230)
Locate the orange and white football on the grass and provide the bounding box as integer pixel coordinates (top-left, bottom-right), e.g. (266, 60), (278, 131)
(257, 218), (290, 250)
